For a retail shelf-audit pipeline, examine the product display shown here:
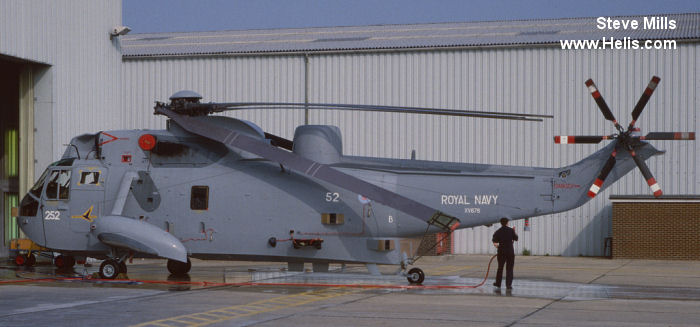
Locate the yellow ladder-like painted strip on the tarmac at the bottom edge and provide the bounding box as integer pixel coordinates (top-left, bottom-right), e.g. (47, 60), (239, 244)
(132, 288), (361, 327)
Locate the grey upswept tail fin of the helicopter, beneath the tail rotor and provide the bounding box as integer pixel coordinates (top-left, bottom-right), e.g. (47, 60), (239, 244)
(553, 140), (663, 212)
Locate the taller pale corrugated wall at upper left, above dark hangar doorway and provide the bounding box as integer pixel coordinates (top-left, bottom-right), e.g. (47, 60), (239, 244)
(0, 0), (122, 169)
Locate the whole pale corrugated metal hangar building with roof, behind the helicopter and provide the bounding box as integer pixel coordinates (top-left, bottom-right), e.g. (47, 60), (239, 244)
(0, 0), (700, 256)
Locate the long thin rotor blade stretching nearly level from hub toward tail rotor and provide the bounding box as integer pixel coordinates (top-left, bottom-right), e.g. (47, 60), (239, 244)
(174, 102), (554, 121)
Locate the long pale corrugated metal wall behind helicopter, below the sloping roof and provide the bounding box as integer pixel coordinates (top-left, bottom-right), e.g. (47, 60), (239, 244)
(120, 43), (700, 256)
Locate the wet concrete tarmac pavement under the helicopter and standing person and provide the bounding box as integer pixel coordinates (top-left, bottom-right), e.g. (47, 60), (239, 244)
(0, 255), (700, 327)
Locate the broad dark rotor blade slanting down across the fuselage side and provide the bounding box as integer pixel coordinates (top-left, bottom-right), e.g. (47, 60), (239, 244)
(155, 104), (459, 230)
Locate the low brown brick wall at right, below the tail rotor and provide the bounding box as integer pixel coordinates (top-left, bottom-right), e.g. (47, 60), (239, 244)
(612, 199), (700, 260)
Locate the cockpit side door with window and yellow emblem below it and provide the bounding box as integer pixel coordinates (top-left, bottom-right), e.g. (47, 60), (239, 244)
(70, 166), (107, 234)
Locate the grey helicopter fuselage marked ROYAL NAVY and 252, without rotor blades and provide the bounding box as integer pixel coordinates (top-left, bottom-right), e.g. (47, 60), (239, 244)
(20, 118), (657, 264)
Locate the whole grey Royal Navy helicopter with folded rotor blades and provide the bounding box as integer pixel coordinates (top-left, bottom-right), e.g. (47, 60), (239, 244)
(13, 77), (695, 283)
